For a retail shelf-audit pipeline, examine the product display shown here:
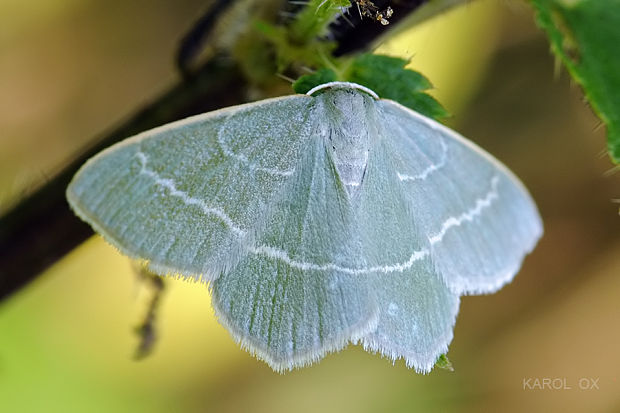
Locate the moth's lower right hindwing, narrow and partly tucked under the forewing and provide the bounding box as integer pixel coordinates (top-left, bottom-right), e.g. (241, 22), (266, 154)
(357, 118), (459, 373)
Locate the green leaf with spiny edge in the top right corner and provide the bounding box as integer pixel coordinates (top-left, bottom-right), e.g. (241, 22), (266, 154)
(532, 0), (620, 163)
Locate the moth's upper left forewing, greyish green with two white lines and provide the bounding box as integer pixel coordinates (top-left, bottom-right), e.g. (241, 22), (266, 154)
(67, 96), (313, 281)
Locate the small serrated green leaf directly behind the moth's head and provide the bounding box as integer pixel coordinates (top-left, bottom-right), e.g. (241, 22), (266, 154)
(343, 54), (448, 119)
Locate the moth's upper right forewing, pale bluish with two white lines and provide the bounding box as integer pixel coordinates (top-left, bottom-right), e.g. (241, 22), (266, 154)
(379, 100), (542, 295)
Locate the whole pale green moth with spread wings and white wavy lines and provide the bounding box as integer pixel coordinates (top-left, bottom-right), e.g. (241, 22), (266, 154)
(67, 82), (542, 372)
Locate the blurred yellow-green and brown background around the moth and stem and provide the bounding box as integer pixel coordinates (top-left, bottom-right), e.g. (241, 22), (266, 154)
(0, 0), (620, 412)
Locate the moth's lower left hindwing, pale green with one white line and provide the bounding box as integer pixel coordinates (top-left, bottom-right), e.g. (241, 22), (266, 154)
(211, 131), (376, 371)
